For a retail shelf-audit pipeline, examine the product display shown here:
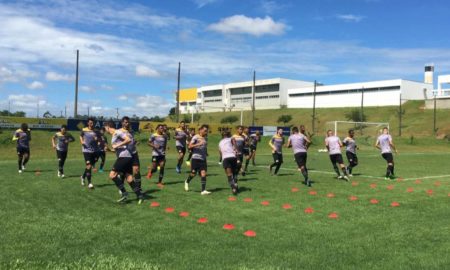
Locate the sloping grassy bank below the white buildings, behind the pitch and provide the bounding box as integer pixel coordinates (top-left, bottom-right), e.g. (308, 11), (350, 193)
(178, 101), (450, 137)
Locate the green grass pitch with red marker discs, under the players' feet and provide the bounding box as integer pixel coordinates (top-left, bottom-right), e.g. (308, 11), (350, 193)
(0, 132), (450, 269)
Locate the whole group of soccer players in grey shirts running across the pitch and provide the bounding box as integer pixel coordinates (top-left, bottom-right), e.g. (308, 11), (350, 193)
(13, 116), (397, 204)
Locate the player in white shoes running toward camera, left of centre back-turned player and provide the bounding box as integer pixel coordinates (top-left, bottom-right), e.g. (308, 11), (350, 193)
(184, 125), (211, 195)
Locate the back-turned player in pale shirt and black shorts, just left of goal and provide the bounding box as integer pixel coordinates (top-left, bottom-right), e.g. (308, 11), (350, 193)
(287, 125), (311, 187)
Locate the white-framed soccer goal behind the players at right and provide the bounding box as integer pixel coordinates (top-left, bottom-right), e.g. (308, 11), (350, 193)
(326, 121), (389, 136)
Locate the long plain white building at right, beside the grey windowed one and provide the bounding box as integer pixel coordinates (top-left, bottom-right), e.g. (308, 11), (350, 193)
(287, 79), (433, 108)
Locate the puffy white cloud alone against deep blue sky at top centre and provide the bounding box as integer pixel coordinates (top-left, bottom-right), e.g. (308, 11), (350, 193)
(208, 15), (287, 37)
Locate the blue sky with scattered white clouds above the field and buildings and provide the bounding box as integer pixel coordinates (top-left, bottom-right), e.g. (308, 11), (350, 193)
(0, 0), (450, 116)
